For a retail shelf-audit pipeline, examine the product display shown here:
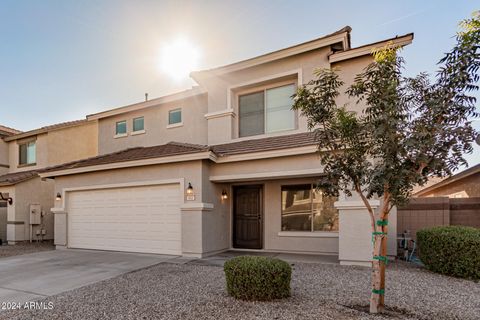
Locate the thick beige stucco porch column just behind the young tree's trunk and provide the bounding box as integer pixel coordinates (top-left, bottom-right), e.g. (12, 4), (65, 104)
(335, 199), (380, 266)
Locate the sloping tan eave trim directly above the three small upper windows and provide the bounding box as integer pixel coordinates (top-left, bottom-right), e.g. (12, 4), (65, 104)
(87, 87), (206, 121)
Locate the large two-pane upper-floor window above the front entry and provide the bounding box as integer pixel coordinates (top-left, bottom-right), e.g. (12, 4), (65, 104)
(238, 84), (296, 137)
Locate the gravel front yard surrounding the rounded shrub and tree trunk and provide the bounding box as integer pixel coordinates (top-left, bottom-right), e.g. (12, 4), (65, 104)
(0, 263), (480, 320)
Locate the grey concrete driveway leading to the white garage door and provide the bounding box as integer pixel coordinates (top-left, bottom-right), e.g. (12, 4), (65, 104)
(0, 249), (175, 303)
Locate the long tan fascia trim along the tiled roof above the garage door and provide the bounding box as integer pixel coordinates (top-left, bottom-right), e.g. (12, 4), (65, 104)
(39, 151), (216, 179)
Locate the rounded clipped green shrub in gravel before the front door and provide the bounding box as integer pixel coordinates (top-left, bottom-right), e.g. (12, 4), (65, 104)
(224, 256), (292, 301)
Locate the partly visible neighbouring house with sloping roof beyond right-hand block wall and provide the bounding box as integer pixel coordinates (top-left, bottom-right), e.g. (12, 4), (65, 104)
(414, 163), (480, 198)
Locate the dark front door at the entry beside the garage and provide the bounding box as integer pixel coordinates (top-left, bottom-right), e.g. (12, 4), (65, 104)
(233, 185), (263, 249)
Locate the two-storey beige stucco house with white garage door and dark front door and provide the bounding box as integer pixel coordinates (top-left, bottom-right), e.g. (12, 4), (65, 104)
(36, 27), (413, 265)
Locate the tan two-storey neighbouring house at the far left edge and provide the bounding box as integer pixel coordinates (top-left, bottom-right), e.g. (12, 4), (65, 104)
(0, 120), (98, 244)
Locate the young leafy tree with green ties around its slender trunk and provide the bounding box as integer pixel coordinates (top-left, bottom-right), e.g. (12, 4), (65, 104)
(293, 13), (480, 313)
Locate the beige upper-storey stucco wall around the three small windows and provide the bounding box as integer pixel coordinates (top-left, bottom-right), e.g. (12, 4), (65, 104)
(98, 94), (207, 154)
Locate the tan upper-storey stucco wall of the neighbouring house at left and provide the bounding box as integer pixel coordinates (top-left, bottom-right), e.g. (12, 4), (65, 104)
(8, 121), (98, 172)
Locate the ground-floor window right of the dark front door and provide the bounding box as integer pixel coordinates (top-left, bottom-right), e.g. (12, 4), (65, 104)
(281, 184), (338, 232)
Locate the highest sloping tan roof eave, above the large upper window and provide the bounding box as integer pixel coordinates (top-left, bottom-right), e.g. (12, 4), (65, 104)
(190, 26), (352, 80)
